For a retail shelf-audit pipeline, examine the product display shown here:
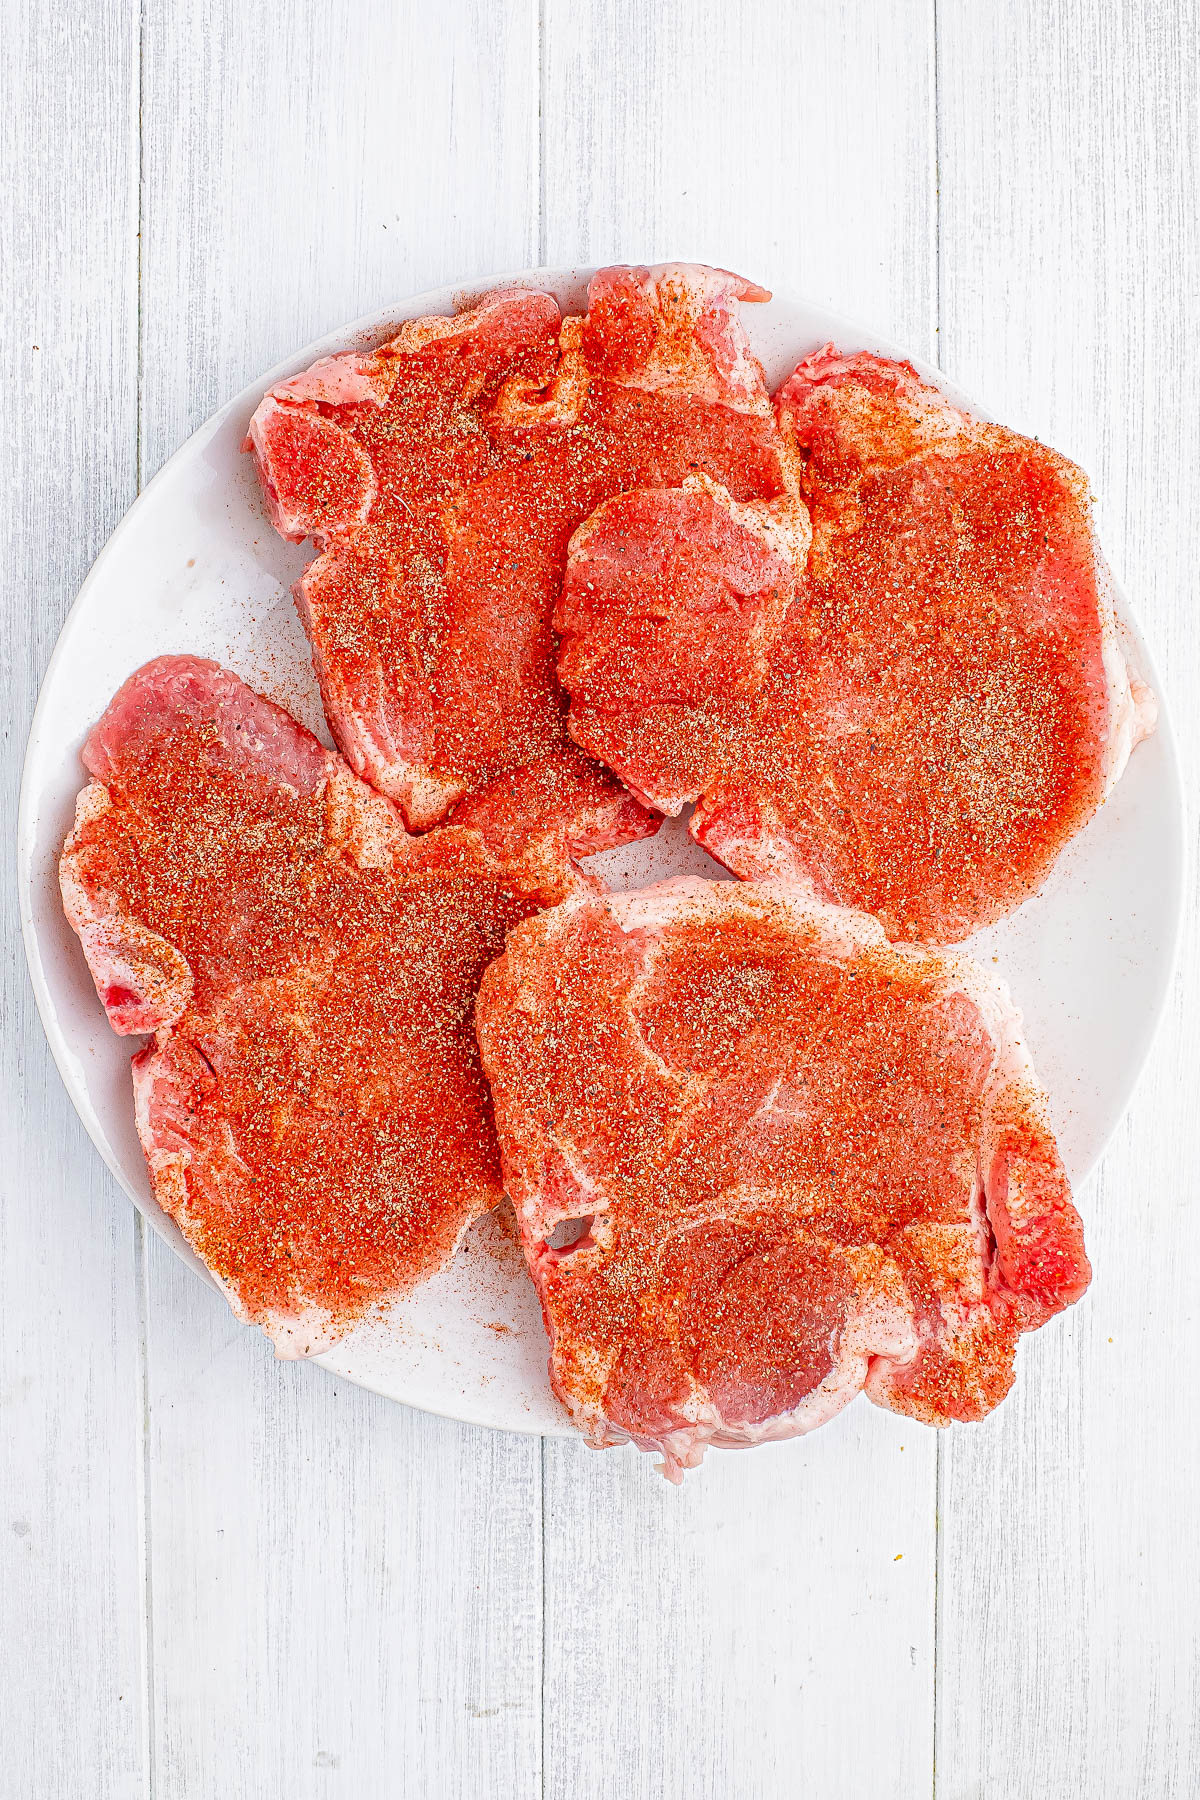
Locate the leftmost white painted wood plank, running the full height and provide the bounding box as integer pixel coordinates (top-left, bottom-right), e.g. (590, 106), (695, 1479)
(0, 0), (146, 1800)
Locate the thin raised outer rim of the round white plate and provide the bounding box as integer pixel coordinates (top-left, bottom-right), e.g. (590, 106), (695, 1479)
(14, 257), (1189, 1436)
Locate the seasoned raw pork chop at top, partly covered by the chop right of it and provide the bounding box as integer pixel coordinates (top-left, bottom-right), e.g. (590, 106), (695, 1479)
(248, 266), (793, 853)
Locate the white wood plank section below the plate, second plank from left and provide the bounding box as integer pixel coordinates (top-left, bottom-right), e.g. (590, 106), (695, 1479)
(149, 1246), (542, 1800)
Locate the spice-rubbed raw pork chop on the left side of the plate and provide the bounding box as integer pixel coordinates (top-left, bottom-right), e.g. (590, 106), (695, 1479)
(61, 657), (557, 1355)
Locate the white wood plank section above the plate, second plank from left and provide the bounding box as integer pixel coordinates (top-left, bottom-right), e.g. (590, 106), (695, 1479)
(142, 0), (538, 477)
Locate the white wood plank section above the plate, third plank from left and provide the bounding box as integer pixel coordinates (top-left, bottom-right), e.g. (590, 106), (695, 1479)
(542, 0), (937, 353)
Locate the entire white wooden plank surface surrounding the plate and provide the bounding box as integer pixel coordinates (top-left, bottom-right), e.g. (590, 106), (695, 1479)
(0, 0), (1200, 1800)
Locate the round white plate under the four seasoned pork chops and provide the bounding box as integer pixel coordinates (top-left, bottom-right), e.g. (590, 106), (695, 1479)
(18, 268), (1184, 1433)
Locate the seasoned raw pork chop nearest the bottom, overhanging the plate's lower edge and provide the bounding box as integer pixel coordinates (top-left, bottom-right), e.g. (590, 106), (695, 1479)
(477, 878), (1090, 1474)
